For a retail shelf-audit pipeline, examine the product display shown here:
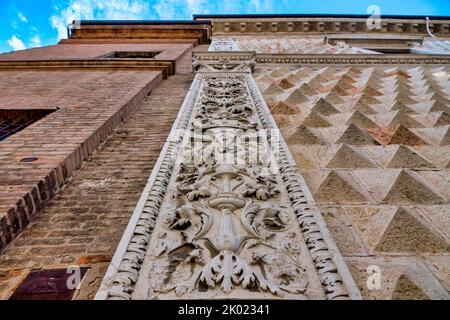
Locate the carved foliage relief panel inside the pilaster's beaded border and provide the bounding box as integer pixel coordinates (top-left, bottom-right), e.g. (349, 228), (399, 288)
(130, 70), (330, 299)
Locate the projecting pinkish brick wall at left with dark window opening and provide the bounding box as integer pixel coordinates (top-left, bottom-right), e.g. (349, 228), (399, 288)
(0, 71), (161, 249)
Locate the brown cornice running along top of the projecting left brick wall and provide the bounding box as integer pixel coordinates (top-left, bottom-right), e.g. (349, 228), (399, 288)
(0, 59), (175, 79)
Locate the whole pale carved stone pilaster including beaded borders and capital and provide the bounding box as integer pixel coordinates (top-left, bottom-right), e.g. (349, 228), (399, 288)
(99, 53), (356, 299)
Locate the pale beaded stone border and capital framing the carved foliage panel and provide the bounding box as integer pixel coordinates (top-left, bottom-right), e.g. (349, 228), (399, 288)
(96, 52), (361, 300)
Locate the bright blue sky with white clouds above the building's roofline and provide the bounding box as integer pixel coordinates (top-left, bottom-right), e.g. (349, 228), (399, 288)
(0, 0), (450, 52)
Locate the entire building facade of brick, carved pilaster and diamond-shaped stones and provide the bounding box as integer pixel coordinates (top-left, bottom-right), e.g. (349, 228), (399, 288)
(0, 15), (450, 300)
